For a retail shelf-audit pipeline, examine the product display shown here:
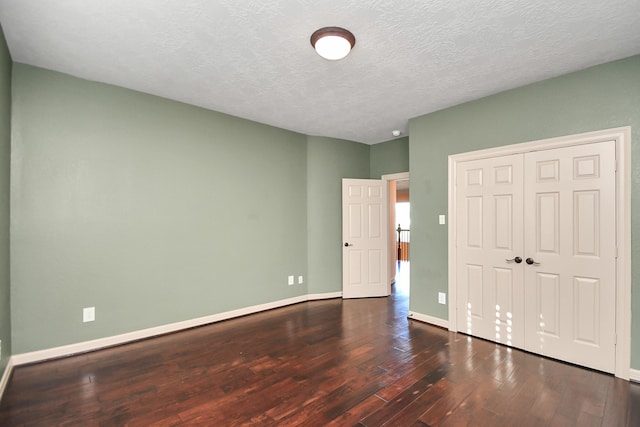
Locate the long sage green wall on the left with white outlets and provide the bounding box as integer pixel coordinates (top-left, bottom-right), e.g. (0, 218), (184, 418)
(11, 64), (316, 354)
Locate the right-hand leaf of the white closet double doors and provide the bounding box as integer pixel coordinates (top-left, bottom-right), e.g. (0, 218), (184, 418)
(523, 141), (616, 372)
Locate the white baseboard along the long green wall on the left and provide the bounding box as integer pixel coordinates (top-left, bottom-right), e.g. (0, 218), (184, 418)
(11, 292), (342, 366)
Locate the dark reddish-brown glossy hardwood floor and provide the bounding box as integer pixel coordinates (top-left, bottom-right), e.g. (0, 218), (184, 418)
(0, 267), (640, 427)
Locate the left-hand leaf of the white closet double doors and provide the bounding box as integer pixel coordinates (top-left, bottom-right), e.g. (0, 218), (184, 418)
(456, 154), (525, 348)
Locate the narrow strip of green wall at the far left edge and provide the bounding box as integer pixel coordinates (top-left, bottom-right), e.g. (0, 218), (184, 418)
(0, 30), (12, 377)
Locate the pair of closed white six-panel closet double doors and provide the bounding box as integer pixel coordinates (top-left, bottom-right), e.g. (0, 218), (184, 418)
(456, 141), (616, 372)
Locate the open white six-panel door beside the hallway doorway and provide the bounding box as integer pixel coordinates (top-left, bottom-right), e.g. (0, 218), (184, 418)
(342, 179), (389, 298)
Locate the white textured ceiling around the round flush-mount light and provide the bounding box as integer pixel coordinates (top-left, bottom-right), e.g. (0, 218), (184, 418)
(0, 0), (640, 144)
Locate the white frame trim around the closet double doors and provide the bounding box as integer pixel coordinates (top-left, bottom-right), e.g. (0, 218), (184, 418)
(448, 126), (631, 380)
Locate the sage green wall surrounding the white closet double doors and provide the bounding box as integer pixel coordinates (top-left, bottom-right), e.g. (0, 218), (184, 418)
(409, 56), (640, 369)
